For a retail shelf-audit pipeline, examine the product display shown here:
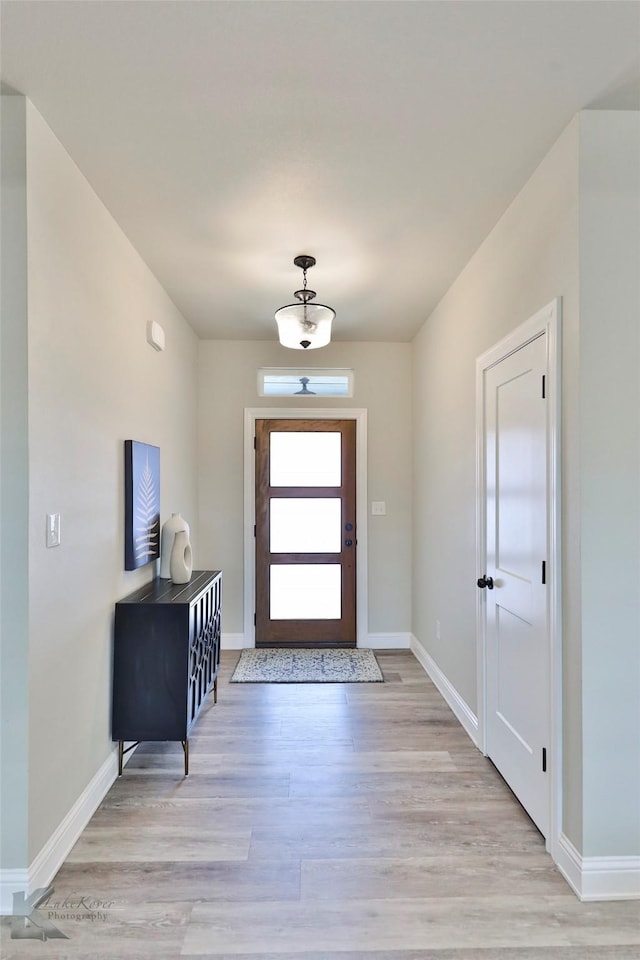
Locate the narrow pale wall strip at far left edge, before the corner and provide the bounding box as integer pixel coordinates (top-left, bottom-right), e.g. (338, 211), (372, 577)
(0, 97), (29, 870)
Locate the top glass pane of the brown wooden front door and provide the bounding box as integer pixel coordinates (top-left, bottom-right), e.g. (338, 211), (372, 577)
(270, 431), (342, 487)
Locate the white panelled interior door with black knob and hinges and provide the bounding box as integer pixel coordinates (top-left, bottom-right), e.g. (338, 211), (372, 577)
(478, 333), (550, 837)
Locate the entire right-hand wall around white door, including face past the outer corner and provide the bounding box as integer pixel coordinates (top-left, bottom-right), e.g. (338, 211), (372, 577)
(413, 112), (640, 857)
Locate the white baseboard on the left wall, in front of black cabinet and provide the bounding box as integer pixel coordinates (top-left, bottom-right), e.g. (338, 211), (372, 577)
(0, 749), (135, 916)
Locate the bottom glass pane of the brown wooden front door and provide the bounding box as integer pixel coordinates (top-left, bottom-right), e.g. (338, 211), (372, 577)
(269, 563), (342, 620)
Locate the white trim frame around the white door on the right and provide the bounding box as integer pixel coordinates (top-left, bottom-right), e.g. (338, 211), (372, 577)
(476, 297), (562, 862)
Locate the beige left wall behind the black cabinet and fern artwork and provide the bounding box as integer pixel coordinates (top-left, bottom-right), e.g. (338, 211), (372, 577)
(3, 98), (197, 866)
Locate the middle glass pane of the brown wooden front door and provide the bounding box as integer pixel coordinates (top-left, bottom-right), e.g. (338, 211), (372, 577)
(269, 497), (342, 553)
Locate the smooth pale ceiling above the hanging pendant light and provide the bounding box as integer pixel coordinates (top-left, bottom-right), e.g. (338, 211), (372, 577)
(1, 0), (640, 341)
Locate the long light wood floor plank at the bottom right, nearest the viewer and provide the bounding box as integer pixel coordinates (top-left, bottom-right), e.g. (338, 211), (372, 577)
(183, 895), (640, 956)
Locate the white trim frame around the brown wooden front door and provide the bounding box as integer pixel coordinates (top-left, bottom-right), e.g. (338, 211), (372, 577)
(244, 407), (369, 647)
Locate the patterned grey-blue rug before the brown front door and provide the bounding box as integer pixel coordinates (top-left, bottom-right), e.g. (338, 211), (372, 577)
(231, 647), (384, 683)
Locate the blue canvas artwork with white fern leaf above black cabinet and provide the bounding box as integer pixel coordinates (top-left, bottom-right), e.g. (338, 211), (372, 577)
(124, 440), (160, 570)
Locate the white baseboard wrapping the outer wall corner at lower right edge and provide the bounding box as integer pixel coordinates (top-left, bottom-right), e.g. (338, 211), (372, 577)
(556, 834), (640, 900)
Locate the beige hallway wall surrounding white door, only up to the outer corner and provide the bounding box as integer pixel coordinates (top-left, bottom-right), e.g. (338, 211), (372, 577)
(413, 118), (578, 711)
